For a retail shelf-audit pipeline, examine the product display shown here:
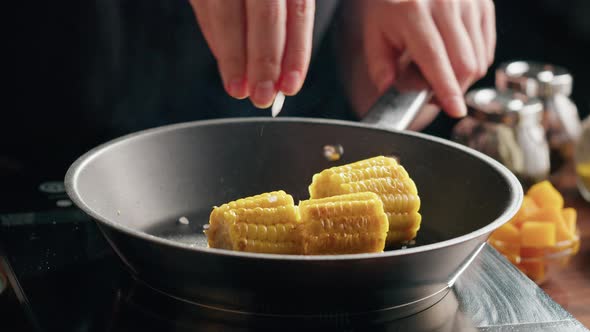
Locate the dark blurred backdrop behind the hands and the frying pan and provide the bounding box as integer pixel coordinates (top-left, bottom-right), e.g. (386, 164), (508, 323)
(0, 0), (590, 182)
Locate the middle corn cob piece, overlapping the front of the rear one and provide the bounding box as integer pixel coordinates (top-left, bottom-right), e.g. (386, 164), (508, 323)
(299, 192), (389, 255)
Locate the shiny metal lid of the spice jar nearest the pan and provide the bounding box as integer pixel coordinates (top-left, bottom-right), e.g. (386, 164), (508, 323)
(465, 88), (543, 124)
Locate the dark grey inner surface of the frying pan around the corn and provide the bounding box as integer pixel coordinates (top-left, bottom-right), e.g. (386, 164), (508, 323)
(74, 120), (513, 252)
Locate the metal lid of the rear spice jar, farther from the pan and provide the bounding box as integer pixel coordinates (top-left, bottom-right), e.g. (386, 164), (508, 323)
(496, 61), (573, 98)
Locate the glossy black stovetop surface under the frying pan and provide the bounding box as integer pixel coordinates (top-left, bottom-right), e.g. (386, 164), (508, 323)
(0, 181), (588, 332)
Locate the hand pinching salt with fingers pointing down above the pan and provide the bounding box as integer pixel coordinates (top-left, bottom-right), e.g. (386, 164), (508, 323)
(190, 0), (315, 108)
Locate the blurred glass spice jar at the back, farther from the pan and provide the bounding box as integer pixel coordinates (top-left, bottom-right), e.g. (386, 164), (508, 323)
(496, 61), (581, 172)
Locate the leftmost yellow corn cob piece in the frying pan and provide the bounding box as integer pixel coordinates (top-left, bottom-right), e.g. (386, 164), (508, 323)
(206, 190), (303, 254)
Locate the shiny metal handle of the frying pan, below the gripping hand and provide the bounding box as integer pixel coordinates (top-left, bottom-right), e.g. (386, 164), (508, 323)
(361, 87), (431, 130)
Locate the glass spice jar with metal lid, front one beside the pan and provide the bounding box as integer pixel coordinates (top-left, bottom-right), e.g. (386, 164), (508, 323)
(452, 89), (550, 187)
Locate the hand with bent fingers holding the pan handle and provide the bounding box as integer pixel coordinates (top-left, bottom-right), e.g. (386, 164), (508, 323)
(364, 0), (496, 117)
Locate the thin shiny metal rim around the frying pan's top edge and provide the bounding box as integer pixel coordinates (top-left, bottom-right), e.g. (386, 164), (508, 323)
(64, 117), (524, 262)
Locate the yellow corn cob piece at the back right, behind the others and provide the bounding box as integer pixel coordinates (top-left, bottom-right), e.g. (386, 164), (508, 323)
(309, 156), (422, 245)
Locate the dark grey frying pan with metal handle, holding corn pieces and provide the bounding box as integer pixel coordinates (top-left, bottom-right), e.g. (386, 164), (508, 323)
(65, 81), (523, 318)
